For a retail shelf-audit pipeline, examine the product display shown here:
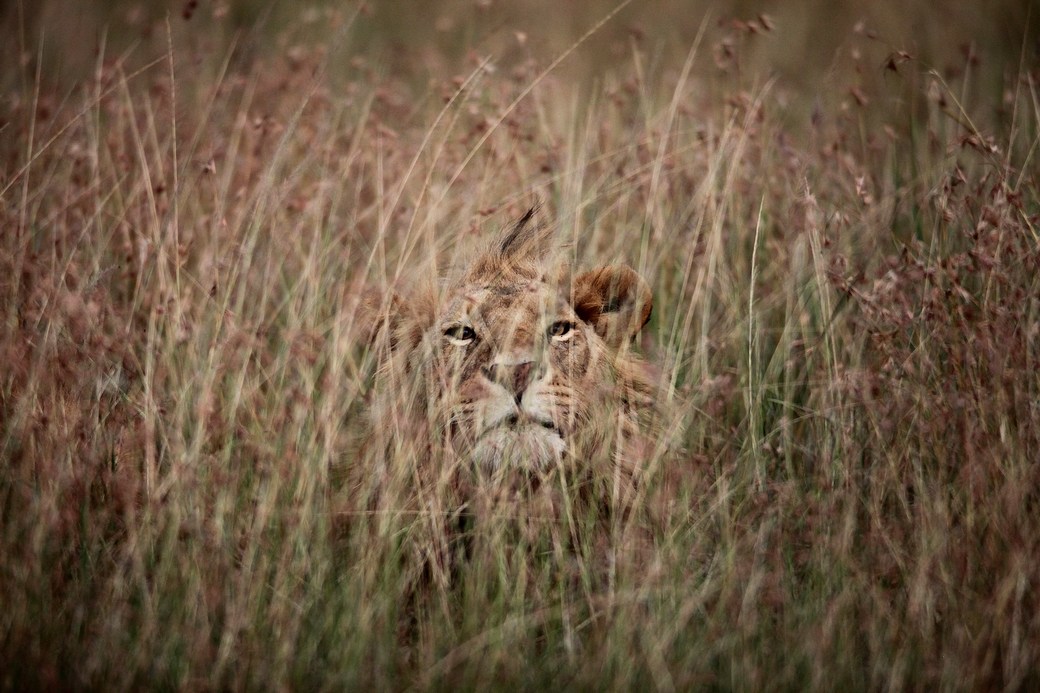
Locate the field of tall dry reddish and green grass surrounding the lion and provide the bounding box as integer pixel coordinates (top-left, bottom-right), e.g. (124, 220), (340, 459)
(0, 0), (1040, 690)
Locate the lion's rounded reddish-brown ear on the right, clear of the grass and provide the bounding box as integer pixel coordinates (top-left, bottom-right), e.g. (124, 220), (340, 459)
(572, 264), (653, 349)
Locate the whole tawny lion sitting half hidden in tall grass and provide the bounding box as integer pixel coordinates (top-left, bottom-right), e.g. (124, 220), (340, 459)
(343, 209), (660, 616)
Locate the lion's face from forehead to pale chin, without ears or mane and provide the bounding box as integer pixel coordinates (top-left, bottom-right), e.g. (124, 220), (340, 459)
(434, 272), (603, 468)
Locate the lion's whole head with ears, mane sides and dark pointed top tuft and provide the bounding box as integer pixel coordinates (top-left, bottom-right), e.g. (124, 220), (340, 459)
(374, 212), (652, 470)
